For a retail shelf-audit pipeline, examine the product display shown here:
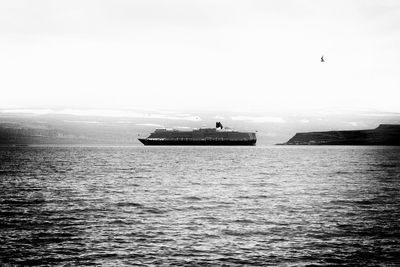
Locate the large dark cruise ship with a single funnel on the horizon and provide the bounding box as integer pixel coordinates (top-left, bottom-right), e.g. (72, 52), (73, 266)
(139, 122), (257, 146)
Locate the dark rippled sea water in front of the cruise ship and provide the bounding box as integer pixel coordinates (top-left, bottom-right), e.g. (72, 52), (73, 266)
(0, 147), (400, 266)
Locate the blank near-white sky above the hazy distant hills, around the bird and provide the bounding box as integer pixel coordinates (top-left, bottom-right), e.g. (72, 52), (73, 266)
(0, 0), (400, 113)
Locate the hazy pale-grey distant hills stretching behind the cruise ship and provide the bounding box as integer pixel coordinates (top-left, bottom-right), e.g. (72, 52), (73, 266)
(0, 109), (400, 146)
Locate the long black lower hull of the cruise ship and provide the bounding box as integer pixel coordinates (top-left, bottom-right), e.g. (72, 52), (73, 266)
(139, 138), (257, 146)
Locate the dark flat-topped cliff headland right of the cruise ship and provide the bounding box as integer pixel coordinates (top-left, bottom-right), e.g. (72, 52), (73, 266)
(284, 124), (400, 146)
